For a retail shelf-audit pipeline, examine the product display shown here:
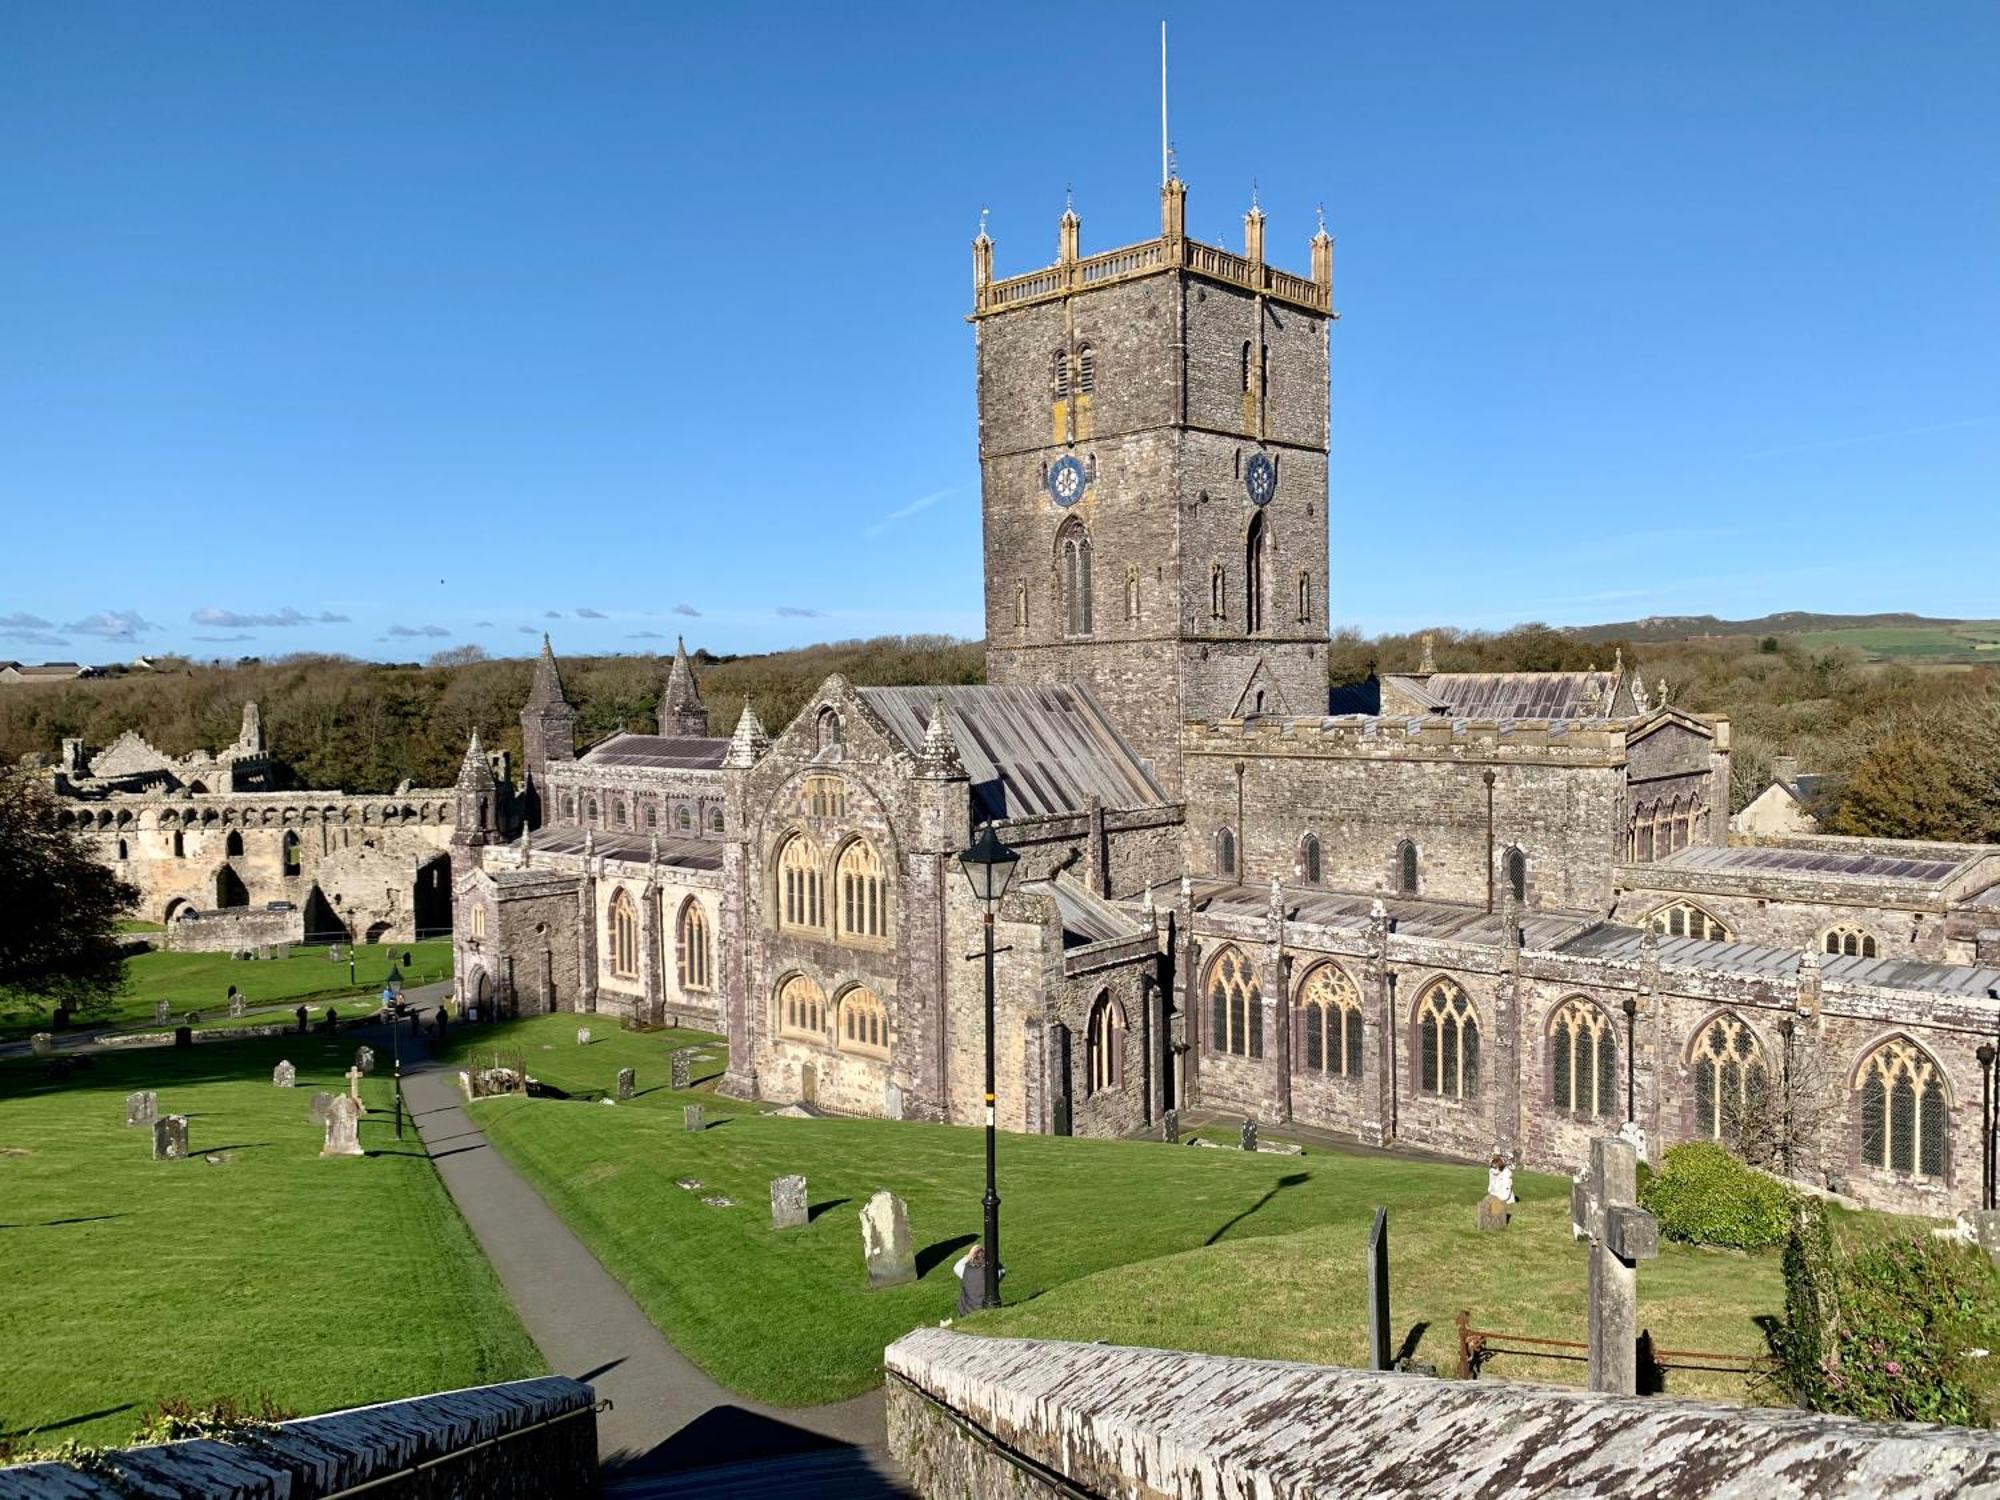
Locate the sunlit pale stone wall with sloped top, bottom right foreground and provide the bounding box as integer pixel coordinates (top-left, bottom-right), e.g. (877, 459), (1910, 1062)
(886, 1328), (2000, 1500)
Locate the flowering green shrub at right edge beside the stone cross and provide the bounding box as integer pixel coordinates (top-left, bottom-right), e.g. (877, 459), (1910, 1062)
(1774, 1204), (2000, 1426)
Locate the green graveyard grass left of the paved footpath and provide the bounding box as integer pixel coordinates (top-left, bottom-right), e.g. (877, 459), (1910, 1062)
(0, 1032), (542, 1446)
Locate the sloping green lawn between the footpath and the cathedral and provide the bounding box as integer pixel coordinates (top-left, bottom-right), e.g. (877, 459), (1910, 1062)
(470, 1016), (1782, 1404)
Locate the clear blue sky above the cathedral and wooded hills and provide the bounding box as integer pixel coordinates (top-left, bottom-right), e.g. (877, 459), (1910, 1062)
(0, 0), (2000, 660)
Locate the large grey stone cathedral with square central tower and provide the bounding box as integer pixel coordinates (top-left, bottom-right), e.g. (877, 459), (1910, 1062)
(452, 180), (2000, 1216)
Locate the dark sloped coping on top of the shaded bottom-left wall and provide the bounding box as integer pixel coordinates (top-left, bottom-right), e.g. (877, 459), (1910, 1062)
(0, 1376), (596, 1500)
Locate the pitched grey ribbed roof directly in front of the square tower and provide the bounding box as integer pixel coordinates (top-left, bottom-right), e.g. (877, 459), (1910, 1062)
(856, 684), (1168, 820)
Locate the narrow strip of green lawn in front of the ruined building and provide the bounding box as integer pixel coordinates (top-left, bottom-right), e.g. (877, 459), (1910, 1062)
(0, 938), (452, 1038)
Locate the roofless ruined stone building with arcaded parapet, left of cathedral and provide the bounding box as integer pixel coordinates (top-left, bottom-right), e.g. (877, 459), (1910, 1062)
(50, 704), (456, 952)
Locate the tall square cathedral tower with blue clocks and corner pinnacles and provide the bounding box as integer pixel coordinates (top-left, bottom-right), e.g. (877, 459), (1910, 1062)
(972, 180), (1334, 792)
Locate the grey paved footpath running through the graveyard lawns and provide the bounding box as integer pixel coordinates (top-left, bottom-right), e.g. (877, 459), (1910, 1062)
(404, 996), (902, 1500)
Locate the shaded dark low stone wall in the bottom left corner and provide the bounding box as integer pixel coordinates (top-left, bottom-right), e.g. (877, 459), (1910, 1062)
(0, 1376), (598, 1500)
